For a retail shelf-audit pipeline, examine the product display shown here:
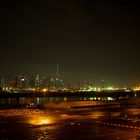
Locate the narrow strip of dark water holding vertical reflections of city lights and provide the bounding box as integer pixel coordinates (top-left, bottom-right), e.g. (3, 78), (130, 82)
(0, 97), (116, 106)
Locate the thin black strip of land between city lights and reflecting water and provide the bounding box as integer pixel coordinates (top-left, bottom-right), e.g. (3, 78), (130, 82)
(0, 91), (140, 98)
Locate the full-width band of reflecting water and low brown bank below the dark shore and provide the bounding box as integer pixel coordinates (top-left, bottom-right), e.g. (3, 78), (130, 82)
(0, 93), (140, 108)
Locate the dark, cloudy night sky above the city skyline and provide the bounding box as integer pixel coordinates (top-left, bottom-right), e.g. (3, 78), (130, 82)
(0, 0), (140, 86)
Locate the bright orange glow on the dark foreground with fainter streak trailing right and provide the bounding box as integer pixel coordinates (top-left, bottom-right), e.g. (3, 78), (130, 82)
(26, 110), (105, 125)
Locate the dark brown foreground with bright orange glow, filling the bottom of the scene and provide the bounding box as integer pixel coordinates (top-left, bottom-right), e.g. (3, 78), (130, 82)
(0, 105), (140, 140)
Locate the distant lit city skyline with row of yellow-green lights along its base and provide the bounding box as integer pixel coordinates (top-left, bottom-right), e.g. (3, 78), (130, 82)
(0, 73), (140, 93)
